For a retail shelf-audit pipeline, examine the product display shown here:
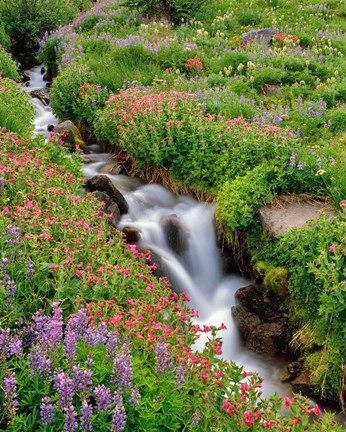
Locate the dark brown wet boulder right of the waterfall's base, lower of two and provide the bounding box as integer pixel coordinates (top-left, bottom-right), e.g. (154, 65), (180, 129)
(246, 322), (287, 354)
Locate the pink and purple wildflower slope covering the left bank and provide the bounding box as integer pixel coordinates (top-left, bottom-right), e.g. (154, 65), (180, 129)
(0, 130), (341, 431)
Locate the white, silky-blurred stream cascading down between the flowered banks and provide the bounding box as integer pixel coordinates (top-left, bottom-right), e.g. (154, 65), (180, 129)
(23, 66), (344, 424)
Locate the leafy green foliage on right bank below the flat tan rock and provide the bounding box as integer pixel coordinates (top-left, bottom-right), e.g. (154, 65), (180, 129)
(250, 210), (346, 401)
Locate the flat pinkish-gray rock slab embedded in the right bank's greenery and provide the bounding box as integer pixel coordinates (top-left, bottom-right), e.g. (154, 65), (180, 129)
(259, 196), (337, 237)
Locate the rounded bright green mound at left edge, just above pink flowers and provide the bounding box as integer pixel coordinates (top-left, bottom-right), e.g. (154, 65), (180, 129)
(0, 77), (35, 138)
